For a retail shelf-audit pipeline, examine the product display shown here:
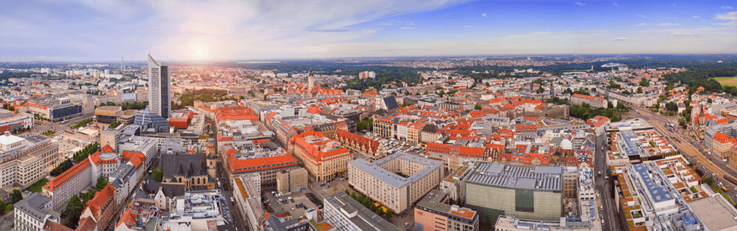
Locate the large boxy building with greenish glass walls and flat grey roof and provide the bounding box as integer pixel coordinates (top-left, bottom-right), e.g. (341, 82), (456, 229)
(466, 162), (563, 226)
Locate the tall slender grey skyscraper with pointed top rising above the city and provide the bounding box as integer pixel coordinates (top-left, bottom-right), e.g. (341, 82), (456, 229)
(148, 54), (171, 119)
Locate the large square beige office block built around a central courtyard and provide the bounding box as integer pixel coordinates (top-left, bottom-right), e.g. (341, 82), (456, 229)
(348, 152), (445, 213)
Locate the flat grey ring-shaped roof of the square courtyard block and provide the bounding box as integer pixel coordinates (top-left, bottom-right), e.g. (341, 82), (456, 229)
(348, 152), (443, 188)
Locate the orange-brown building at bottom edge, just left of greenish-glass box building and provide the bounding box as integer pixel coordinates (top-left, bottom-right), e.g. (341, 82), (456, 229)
(414, 190), (479, 231)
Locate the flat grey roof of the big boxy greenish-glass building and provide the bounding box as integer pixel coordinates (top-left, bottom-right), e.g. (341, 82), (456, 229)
(467, 162), (563, 191)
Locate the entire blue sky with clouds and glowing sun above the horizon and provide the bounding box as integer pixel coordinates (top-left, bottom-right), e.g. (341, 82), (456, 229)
(0, 0), (737, 62)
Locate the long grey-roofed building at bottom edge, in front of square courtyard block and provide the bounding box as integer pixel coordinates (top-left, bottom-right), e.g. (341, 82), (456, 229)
(323, 192), (400, 231)
